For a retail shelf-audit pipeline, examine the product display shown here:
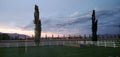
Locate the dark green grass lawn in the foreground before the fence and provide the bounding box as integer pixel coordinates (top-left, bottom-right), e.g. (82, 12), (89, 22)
(0, 46), (120, 57)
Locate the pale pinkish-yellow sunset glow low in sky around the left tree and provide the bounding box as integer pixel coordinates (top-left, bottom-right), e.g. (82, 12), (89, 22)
(0, 27), (62, 37)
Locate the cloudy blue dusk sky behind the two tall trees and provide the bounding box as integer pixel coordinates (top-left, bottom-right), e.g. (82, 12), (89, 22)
(0, 0), (120, 36)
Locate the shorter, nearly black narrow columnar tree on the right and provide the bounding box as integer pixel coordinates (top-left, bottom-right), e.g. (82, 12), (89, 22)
(92, 10), (98, 41)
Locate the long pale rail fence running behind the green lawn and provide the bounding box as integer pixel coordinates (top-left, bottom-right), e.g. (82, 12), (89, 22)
(0, 40), (120, 48)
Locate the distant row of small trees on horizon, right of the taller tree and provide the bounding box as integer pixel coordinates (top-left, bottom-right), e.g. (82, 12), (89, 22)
(42, 34), (120, 40)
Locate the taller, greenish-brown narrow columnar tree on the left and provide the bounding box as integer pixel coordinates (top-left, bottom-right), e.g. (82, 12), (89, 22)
(34, 5), (41, 46)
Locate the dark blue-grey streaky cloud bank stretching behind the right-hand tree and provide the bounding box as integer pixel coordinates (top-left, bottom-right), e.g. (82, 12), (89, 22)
(25, 8), (120, 35)
